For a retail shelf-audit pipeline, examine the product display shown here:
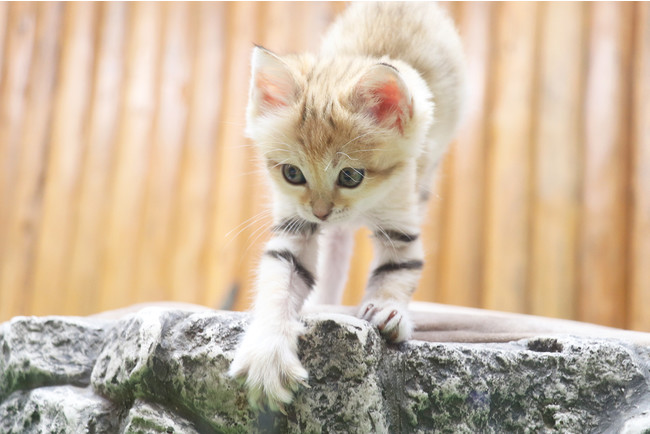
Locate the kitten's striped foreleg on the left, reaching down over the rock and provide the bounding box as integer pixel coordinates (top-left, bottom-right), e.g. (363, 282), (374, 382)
(230, 219), (318, 410)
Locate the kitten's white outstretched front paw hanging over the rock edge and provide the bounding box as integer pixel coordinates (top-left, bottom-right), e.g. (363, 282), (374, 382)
(228, 324), (309, 413)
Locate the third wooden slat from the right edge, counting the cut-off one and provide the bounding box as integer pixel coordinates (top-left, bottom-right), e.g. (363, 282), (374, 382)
(530, 2), (585, 318)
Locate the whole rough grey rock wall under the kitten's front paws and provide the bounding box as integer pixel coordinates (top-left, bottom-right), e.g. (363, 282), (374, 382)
(0, 308), (650, 433)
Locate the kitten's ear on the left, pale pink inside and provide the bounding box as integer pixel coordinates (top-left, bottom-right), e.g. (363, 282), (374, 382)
(250, 47), (298, 115)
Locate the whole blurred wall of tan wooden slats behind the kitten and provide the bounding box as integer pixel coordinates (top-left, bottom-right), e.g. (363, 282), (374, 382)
(0, 3), (650, 331)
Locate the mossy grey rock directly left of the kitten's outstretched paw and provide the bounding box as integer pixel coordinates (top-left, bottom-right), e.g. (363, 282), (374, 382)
(92, 309), (256, 430)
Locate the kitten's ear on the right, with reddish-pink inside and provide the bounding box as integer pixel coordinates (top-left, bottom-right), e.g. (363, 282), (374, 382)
(351, 63), (413, 134)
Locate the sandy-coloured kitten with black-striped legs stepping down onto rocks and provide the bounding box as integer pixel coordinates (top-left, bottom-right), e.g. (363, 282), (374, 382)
(230, 3), (465, 410)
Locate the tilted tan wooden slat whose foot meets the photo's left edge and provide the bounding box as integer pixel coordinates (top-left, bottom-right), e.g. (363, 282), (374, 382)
(0, 3), (63, 318)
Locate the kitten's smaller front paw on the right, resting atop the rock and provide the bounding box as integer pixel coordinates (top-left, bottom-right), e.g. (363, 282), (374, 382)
(359, 300), (413, 342)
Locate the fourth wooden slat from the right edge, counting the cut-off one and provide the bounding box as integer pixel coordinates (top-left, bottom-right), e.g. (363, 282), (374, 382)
(483, 2), (539, 312)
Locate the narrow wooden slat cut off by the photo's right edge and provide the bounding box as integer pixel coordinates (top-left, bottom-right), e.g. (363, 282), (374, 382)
(627, 2), (650, 331)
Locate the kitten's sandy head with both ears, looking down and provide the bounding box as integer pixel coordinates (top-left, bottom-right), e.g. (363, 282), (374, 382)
(246, 47), (432, 223)
